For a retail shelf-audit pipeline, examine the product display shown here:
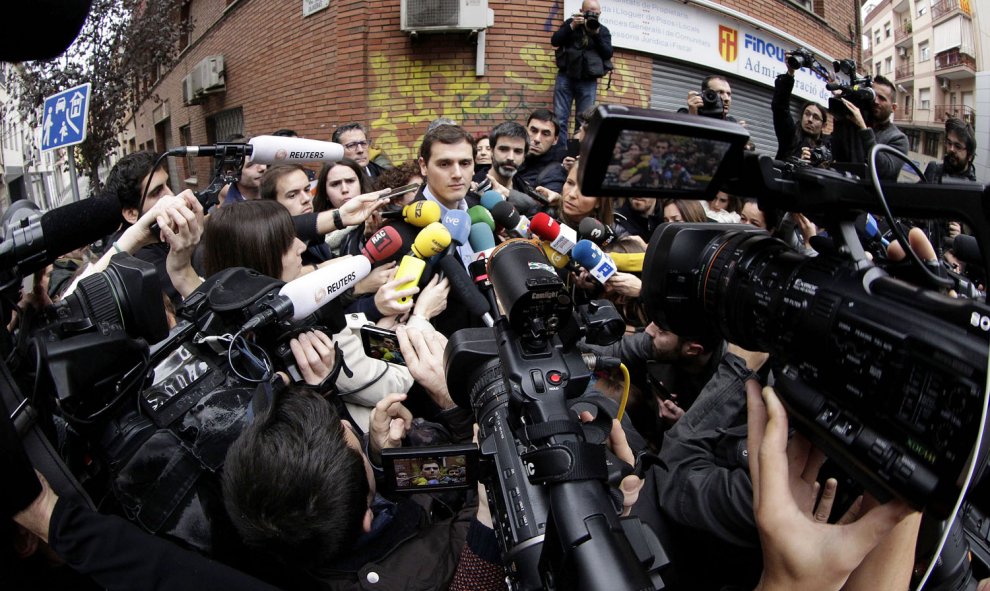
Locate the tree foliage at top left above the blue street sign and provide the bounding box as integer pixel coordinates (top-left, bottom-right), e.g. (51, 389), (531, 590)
(8, 0), (191, 188)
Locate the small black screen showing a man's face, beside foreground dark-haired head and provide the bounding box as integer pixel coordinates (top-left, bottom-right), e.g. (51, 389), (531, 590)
(382, 443), (479, 493)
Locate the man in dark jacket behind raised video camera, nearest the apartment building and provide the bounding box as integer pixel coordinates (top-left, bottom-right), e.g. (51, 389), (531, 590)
(832, 76), (908, 181)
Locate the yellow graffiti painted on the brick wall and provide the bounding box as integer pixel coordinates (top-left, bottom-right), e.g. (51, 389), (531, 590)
(368, 43), (650, 163)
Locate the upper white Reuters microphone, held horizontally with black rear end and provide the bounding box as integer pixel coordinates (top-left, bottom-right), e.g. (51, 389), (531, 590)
(168, 135), (344, 164)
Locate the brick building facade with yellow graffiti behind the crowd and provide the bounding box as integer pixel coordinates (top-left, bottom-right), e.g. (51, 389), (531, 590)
(125, 0), (859, 189)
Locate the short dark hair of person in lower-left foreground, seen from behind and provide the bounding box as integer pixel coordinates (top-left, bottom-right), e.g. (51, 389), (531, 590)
(223, 388), (369, 568)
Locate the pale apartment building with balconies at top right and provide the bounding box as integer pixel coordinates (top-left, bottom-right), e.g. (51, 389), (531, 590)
(862, 0), (990, 180)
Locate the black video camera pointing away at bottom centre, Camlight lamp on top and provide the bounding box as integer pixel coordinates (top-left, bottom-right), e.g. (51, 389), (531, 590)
(444, 239), (667, 589)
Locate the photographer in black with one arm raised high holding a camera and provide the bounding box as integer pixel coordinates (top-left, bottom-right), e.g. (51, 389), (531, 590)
(770, 52), (832, 162)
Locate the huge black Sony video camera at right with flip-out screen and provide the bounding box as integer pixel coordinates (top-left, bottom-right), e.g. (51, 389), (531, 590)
(580, 107), (990, 584)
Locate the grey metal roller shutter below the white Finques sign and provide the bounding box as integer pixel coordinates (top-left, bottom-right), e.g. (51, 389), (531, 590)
(650, 59), (803, 156)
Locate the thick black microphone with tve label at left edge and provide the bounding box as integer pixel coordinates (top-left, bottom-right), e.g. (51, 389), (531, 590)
(0, 197), (122, 277)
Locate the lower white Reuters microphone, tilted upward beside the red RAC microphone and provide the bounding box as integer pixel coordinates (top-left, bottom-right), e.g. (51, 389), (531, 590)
(241, 256), (371, 331)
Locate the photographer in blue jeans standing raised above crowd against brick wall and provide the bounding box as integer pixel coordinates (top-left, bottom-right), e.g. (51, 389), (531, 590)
(550, 0), (612, 144)
